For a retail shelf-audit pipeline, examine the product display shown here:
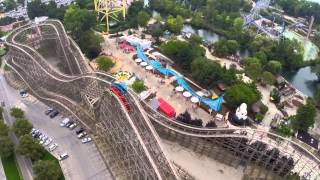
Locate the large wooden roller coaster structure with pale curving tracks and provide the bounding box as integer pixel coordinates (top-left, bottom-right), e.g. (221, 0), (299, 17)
(5, 20), (320, 179)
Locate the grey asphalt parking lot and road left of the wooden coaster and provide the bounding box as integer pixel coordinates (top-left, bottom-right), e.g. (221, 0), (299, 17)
(0, 76), (112, 180)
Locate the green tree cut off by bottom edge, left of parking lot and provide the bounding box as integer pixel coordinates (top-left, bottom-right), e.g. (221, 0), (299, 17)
(33, 160), (63, 180)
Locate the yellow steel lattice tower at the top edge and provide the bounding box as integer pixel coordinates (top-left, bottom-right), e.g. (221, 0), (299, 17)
(94, 0), (127, 33)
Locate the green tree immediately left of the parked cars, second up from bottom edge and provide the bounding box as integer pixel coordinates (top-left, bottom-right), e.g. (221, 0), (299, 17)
(16, 134), (46, 161)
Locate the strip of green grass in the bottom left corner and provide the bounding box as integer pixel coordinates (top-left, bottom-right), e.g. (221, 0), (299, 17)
(1, 156), (21, 180)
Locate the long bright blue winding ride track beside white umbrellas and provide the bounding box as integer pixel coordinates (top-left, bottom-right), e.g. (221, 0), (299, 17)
(134, 44), (223, 112)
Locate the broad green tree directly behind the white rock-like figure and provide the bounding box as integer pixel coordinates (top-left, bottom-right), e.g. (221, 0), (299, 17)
(225, 82), (261, 108)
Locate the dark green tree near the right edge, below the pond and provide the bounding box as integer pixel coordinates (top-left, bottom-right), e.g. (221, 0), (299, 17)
(291, 100), (316, 132)
